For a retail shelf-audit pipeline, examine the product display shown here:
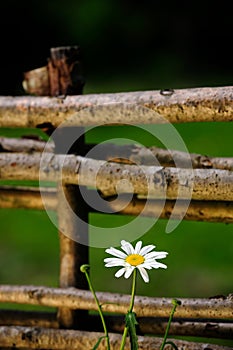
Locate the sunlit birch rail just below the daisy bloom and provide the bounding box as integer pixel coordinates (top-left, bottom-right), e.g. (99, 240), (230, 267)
(0, 285), (233, 319)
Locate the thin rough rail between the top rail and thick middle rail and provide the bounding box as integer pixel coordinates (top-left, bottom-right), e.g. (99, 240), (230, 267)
(0, 137), (233, 171)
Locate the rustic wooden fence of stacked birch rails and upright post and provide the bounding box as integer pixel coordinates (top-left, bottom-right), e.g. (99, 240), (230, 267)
(0, 47), (233, 350)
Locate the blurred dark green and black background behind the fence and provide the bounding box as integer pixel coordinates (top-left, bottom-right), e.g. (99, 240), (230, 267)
(0, 0), (233, 344)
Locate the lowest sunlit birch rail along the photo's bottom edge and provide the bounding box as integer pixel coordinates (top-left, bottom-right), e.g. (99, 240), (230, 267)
(0, 326), (231, 350)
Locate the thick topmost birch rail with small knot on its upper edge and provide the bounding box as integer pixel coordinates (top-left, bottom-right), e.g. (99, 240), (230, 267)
(0, 86), (233, 128)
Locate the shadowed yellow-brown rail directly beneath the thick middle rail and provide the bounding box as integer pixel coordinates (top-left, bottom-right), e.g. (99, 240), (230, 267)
(0, 186), (233, 223)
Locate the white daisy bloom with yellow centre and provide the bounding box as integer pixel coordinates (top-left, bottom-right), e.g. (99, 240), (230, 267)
(104, 240), (168, 283)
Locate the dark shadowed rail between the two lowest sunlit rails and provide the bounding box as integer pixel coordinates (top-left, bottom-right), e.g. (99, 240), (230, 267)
(0, 310), (233, 339)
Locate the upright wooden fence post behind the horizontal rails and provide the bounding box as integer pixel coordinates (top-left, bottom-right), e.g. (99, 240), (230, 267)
(48, 46), (88, 328)
